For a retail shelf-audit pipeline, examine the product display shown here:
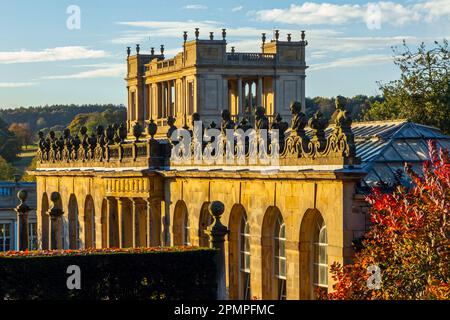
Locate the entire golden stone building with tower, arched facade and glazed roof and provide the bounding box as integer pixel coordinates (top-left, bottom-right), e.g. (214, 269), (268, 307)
(33, 31), (448, 299)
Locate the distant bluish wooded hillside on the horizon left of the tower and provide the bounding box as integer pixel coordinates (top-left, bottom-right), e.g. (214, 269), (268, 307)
(0, 104), (125, 131)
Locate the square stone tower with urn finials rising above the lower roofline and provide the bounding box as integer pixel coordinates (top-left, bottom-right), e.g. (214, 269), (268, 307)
(127, 29), (308, 134)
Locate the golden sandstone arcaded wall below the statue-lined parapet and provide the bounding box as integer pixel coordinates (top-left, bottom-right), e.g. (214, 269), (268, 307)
(37, 171), (366, 299)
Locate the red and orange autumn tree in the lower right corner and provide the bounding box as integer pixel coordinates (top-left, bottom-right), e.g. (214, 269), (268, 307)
(326, 142), (450, 300)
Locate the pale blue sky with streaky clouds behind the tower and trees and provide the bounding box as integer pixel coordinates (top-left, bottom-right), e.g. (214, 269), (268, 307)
(0, 0), (450, 108)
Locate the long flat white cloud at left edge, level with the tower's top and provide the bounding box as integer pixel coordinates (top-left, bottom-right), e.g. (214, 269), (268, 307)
(0, 46), (108, 64)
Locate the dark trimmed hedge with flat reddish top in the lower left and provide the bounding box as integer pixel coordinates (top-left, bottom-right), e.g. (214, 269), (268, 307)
(0, 248), (217, 300)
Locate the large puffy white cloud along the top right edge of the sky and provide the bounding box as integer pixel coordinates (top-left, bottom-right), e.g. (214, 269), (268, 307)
(254, 0), (450, 26)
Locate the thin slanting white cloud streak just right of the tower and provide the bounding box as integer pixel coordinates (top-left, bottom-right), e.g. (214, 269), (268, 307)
(309, 54), (392, 71)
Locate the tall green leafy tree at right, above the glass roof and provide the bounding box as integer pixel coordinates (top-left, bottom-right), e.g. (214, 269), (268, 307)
(364, 40), (450, 134)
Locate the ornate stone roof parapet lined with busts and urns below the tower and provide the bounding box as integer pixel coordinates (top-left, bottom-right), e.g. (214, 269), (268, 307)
(38, 97), (360, 169)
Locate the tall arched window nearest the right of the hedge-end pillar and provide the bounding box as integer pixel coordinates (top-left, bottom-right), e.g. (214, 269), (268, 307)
(239, 216), (251, 300)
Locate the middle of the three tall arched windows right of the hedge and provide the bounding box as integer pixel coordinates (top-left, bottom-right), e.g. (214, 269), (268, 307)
(274, 216), (286, 300)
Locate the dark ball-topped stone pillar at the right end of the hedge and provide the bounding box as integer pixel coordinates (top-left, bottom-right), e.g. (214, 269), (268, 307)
(207, 201), (229, 300)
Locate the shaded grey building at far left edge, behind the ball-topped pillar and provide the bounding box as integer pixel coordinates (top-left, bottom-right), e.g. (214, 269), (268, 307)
(0, 181), (38, 251)
